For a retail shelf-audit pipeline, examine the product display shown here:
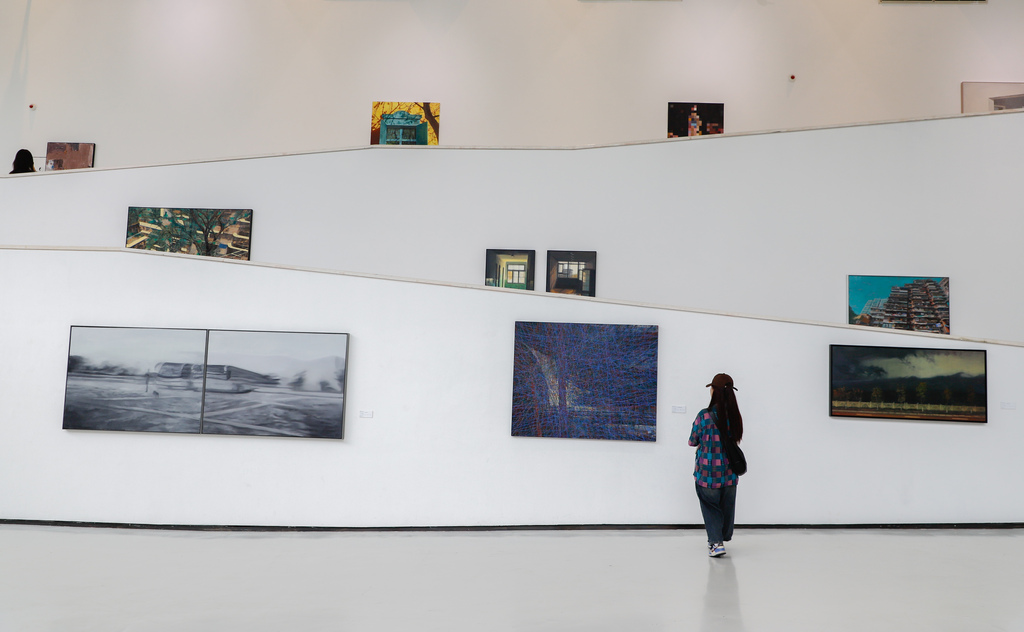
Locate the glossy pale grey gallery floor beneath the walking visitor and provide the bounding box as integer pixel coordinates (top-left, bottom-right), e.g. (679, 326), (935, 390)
(0, 525), (1024, 632)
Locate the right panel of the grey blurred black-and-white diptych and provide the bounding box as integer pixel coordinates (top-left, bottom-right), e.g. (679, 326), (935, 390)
(203, 331), (348, 438)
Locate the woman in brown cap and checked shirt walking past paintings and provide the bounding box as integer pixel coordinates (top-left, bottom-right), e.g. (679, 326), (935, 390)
(689, 373), (743, 557)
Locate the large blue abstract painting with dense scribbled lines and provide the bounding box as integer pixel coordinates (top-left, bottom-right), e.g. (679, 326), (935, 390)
(512, 322), (657, 441)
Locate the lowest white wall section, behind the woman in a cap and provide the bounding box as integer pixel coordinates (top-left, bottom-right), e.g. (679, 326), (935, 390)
(0, 248), (1024, 526)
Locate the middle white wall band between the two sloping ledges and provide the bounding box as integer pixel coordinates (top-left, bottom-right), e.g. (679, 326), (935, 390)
(0, 113), (1024, 342)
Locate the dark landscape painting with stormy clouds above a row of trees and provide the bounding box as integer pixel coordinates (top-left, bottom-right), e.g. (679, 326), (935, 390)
(828, 344), (988, 423)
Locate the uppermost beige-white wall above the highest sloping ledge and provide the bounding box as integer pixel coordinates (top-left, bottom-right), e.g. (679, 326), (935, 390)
(0, 0), (1024, 167)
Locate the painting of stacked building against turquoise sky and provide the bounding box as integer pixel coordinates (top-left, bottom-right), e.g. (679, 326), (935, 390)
(848, 275), (949, 334)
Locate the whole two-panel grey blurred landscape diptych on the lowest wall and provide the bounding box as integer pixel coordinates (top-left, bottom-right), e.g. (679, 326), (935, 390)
(63, 326), (348, 438)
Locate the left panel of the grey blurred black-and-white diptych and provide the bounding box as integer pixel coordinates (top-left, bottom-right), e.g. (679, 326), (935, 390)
(63, 327), (206, 432)
